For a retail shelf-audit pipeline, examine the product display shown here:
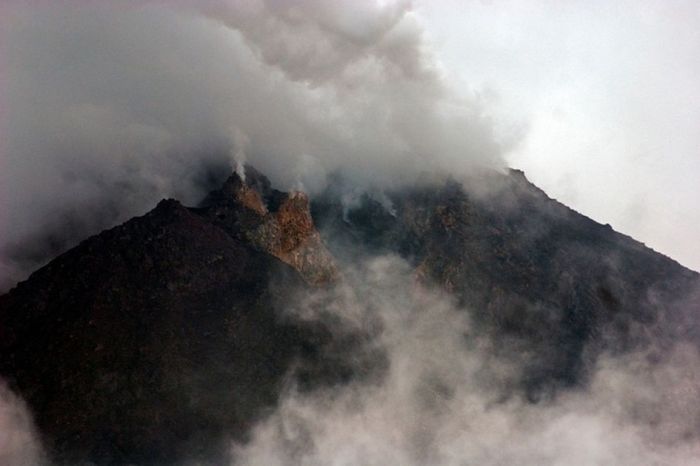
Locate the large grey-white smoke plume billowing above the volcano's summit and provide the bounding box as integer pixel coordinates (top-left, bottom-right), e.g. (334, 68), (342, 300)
(0, 0), (501, 292)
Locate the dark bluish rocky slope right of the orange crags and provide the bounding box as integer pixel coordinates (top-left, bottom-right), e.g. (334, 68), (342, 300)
(313, 170), (700, 400)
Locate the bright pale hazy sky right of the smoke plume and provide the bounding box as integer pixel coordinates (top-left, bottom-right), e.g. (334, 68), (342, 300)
(417, 0), (700, 270)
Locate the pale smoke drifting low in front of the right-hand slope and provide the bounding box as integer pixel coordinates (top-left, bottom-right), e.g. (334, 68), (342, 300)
(233, 257), (700, 466)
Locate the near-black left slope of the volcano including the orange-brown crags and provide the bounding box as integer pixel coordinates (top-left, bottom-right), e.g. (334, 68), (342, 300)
(0, 172), (350, 464)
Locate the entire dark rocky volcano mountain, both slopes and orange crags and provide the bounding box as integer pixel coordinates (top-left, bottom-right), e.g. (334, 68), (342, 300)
(0, 164), (700, 464)
